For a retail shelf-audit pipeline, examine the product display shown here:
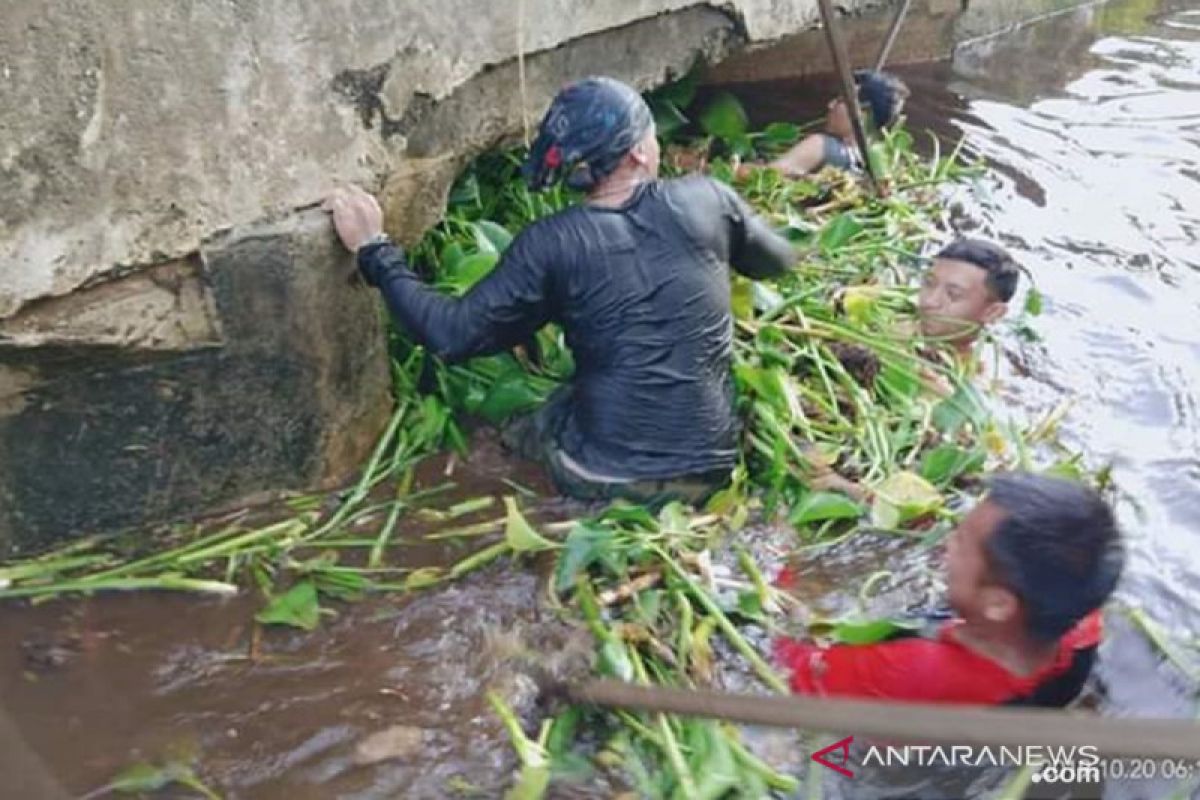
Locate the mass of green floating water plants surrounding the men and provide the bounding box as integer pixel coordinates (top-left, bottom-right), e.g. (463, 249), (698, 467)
(0, 76), (1132, 799)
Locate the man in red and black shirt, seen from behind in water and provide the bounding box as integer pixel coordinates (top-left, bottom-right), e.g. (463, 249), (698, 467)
(775, 473), (1124, 706)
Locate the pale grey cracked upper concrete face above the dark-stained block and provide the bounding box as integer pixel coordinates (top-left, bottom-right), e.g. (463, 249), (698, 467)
(0, 0), (878, 318)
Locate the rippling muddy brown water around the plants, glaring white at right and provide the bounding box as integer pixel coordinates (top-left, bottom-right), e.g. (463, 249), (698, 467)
(0, 0), (1200, 800)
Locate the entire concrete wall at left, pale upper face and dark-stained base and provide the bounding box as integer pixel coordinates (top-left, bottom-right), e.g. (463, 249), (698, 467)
(0, 0), (902, 553)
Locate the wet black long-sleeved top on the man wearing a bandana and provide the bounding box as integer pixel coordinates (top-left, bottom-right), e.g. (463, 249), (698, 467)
(359, 176), (794, 479)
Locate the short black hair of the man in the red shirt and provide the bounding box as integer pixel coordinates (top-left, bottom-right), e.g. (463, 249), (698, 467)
(984, 473), (1124, 642)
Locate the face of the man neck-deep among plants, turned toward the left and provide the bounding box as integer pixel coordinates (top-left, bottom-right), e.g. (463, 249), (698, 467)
(917, 258), (1008, 341)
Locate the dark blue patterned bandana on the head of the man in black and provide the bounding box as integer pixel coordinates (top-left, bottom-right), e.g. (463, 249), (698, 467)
(522, 78), (654, 192)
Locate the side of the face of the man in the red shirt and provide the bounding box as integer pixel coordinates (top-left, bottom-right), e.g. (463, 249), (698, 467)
(946, 500), (1019, 625)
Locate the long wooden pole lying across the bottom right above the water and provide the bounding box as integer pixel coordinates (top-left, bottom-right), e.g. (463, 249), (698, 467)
(562, 680), (1200, 772)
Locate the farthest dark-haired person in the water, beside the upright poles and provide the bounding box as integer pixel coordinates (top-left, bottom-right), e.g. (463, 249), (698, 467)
(768, 71), (910, 178)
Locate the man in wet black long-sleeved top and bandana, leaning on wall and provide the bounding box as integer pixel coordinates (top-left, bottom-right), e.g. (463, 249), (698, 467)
(326, 78), (794, 503)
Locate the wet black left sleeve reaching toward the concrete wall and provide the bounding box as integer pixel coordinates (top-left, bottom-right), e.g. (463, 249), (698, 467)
(358, 227), (552, 362)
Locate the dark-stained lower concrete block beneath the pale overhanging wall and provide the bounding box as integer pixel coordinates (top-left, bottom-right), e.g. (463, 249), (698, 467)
(0, 211), (389, 552)
